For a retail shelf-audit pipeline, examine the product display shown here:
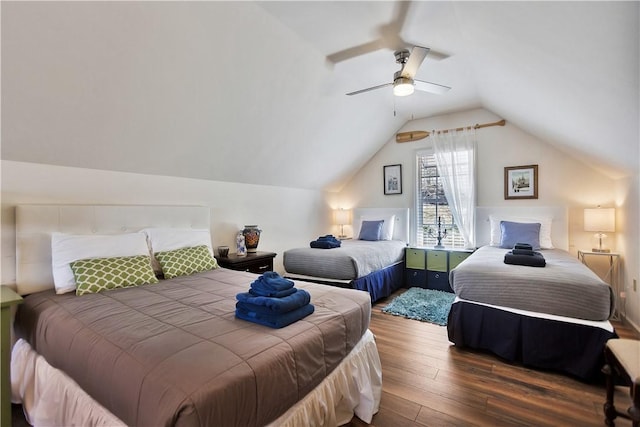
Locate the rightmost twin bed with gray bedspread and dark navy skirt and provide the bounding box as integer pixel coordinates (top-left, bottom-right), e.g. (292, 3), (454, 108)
(447, 208), (616, 381)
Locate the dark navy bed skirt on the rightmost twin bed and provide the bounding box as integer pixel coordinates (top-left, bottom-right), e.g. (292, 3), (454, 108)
(447, 301), (617, 382)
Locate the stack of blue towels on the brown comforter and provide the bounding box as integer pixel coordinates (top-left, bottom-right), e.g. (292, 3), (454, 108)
(236, 271), (315, 328)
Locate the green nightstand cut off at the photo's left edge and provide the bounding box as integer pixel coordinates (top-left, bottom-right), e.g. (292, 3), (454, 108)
(0, 285), (22, 426)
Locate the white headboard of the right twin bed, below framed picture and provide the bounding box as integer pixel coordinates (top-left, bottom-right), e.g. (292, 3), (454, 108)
(476, 206), (569, 250)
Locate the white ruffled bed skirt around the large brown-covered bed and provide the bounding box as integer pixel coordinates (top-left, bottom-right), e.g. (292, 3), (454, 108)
(11, 330), (382, 427)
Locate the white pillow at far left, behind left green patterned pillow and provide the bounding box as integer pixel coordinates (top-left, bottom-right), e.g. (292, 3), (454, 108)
(51, 233), (149, 294)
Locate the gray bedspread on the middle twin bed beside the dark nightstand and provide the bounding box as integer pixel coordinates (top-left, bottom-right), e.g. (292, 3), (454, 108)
(283, 240), (407, 280)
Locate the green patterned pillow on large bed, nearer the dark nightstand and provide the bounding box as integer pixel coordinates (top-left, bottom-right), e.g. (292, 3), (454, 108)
(155, 245), (218, 279)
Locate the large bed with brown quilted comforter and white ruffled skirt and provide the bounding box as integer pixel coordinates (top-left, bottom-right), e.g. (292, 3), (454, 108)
(11, 206), (381, 426)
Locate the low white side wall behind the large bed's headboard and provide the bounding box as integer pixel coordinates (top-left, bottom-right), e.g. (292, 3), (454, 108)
(2, 160), (332, 284)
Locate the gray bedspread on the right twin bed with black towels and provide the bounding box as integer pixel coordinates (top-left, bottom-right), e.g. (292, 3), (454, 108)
(449, 246), (615, 321)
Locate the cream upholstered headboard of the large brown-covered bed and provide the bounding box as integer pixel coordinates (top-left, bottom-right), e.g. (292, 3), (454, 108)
(16, 205), (210, 295)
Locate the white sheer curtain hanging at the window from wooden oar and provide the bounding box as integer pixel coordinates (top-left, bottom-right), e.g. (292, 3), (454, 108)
(429, 128), (476, 248)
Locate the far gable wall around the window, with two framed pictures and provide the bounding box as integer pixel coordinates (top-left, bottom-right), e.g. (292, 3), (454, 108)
(333, 109), (640, 324)
